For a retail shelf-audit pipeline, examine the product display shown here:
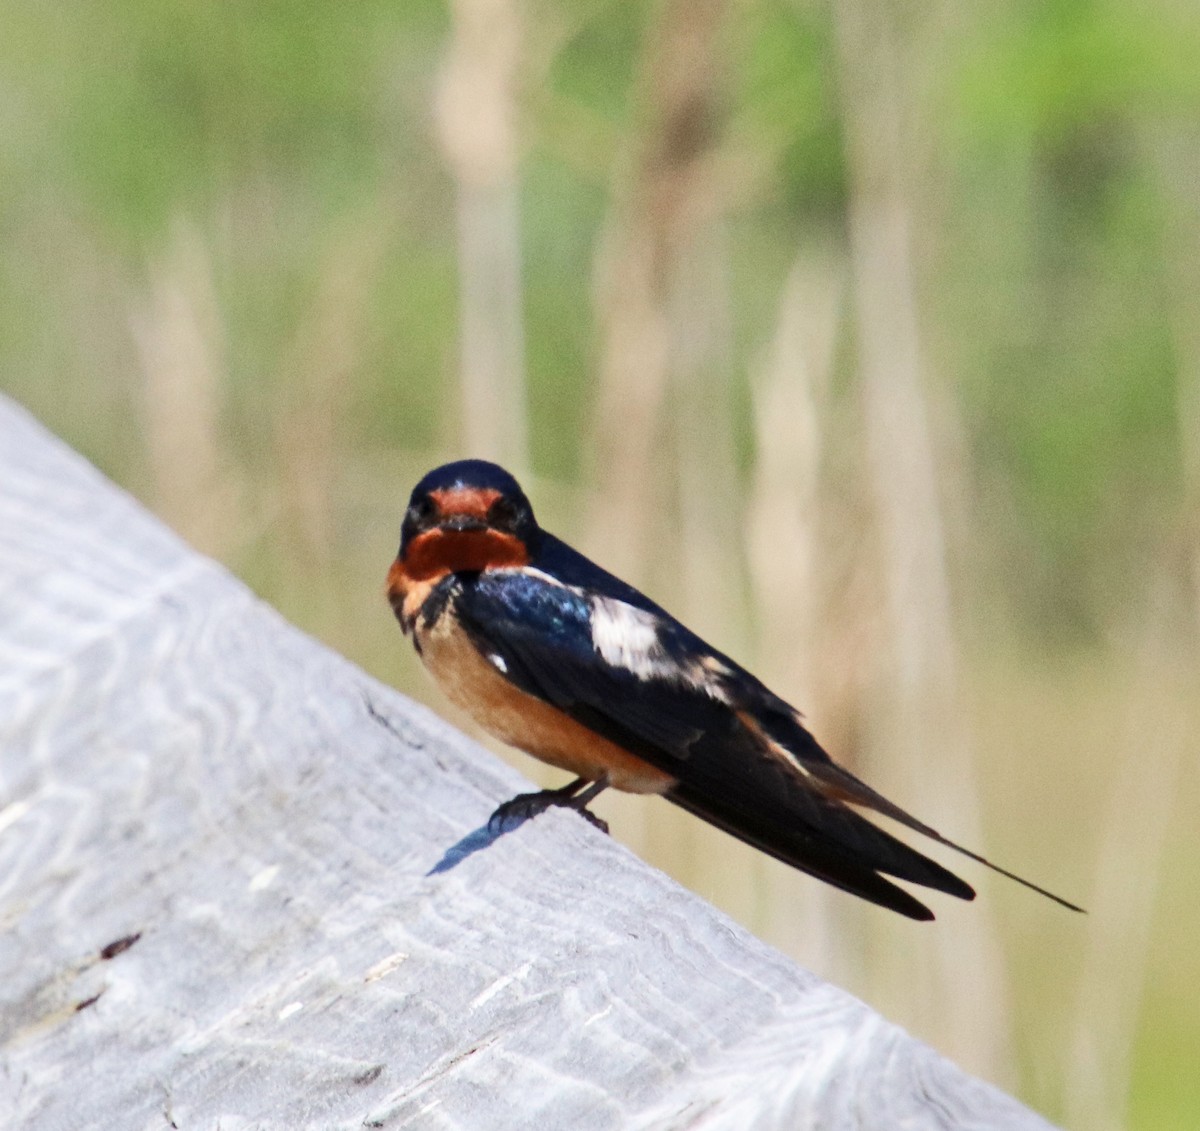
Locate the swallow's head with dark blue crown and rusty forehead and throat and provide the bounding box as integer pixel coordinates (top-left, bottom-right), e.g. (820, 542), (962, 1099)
(394, 460), (538, 581)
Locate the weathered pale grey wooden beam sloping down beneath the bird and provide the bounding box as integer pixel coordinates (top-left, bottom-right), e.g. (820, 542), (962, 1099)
(0, 401), (1046, 1131)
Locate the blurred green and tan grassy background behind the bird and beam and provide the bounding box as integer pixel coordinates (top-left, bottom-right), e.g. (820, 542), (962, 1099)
(0, 0), (1200, 1131)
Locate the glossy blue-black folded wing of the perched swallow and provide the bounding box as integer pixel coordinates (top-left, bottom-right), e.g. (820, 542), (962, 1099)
(454, 566), (974, 918)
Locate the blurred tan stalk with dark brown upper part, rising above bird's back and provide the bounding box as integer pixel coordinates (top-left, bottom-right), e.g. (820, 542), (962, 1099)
(590, 0), (727, 579)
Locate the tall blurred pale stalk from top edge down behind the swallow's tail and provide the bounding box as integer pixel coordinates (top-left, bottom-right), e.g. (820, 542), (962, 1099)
(836, 0), (1012, 1082)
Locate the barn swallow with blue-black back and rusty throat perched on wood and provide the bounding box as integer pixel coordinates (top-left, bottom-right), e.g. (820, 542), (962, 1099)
(388, 460), (1081, 920)
